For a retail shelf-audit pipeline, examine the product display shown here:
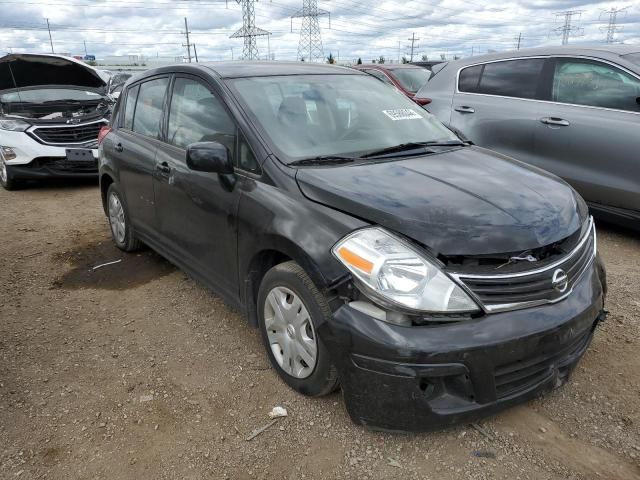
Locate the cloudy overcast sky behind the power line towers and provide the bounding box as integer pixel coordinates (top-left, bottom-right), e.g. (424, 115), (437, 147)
(0, 0), (640, 62)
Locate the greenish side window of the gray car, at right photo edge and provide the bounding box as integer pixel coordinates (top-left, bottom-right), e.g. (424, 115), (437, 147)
(552, 60), (640, 112)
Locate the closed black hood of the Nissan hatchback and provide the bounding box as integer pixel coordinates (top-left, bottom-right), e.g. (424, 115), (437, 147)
(296, 147), (587, 256)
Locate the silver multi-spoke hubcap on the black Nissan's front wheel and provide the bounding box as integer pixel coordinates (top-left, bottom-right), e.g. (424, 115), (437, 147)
(264, 287), (318, 378)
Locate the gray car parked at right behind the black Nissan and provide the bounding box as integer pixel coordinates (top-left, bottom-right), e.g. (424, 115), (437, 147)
(416, 45), (640, 227)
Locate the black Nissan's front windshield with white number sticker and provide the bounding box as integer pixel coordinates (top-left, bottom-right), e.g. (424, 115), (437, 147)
(230, 75), (459, 162)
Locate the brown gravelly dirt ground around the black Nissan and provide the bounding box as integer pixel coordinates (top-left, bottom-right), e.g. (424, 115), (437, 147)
(0, 184), (640, 480)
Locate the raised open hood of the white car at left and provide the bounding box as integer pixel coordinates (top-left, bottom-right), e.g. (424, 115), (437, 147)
(0, 53), (107, 92)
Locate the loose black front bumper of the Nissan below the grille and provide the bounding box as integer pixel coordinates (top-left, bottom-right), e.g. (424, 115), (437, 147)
(318, 262), (604, 431)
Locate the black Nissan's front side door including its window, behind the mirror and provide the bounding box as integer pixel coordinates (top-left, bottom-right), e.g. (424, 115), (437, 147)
(154, 76), (240, 297)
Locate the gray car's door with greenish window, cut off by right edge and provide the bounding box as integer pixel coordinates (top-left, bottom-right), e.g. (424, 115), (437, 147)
(536, 57), (640, 211)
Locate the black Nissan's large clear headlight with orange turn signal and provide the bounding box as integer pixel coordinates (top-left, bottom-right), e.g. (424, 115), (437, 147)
(332, 227), (478, 313)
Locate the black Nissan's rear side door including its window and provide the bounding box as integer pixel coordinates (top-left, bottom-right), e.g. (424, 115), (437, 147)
(110, 76), (169, 235)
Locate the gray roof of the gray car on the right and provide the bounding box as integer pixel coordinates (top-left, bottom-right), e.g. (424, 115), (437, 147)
(444, 45), (640, 65)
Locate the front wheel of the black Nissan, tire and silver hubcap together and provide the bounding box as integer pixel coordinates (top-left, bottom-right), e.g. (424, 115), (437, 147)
(257, 261), (338, 397)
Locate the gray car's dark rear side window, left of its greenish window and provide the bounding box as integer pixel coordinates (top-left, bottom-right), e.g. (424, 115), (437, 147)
(459, 58), (545, 98)
